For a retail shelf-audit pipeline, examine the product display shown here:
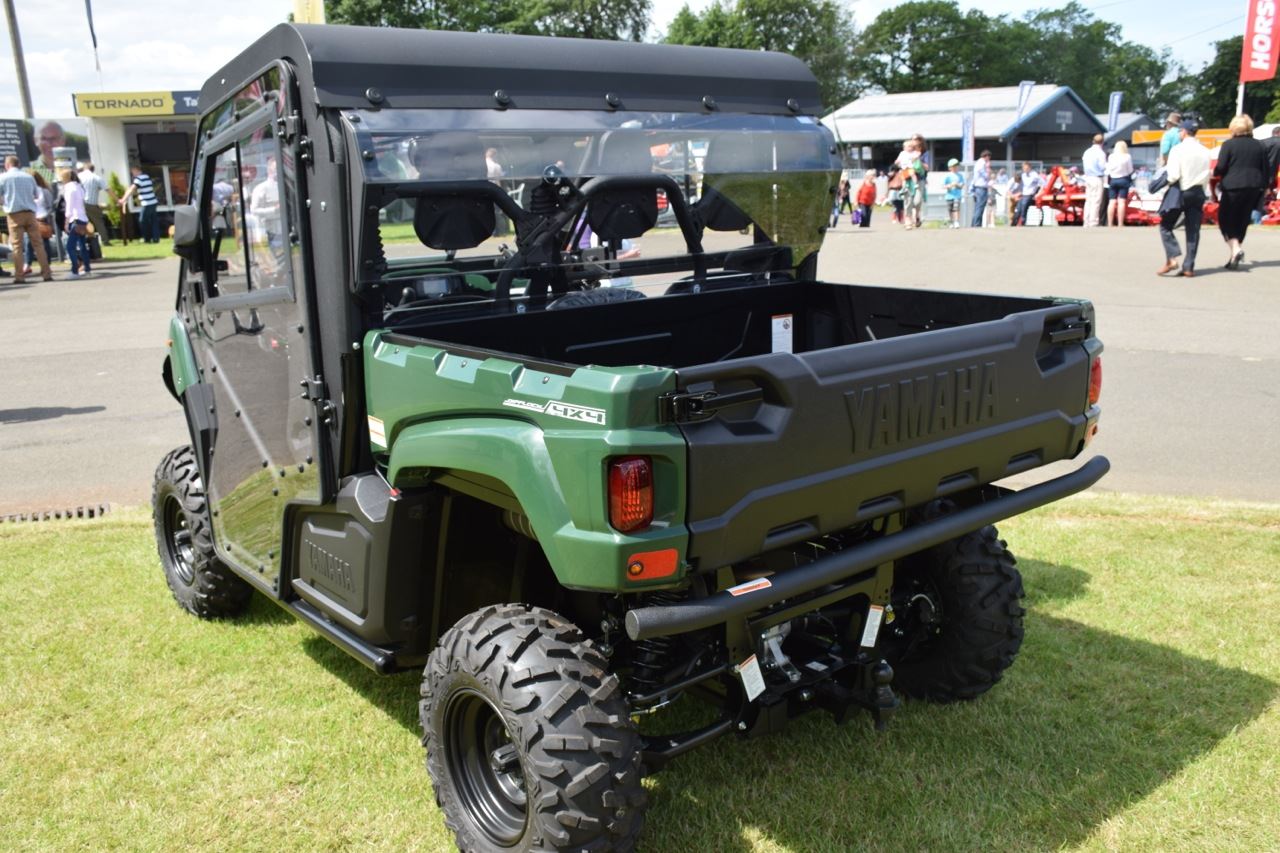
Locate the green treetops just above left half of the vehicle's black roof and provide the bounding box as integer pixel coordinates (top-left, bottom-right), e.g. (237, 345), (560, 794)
(328, 0), (652, 41)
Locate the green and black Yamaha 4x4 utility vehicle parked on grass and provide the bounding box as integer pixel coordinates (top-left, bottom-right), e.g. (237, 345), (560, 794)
(155, 26), (1107, 850)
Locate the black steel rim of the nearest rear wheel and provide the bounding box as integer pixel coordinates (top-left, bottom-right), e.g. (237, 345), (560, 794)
(444, 688), (529, 847)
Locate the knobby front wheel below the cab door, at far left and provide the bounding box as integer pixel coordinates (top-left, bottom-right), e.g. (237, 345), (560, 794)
(151, 444), (253, 619)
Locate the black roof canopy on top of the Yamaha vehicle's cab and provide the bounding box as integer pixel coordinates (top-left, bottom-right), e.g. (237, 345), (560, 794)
(200, 24), (822, 115)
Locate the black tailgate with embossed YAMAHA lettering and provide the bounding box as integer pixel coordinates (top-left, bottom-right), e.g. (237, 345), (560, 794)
(668, 302), (1101, 567)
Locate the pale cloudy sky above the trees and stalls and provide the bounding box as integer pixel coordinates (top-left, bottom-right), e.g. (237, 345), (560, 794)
(0, 0), (1247, 118)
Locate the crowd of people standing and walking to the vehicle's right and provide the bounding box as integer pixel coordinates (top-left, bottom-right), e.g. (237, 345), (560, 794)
(831, 113), (1280, 278)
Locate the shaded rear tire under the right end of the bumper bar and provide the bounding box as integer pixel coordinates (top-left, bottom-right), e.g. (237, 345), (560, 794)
(884, 525), (1027, 702)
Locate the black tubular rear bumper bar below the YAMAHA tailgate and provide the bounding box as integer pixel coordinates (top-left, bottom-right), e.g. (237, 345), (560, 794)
(626, 456), (1111, 640)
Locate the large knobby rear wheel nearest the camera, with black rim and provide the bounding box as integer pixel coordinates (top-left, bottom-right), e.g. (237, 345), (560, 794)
(419, 605), (645, 853)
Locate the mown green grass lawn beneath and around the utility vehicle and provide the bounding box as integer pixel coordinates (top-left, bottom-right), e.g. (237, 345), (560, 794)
(0, 496), (1280, 853)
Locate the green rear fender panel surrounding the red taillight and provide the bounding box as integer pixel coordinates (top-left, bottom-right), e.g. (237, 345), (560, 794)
(388, 418), (689, 592)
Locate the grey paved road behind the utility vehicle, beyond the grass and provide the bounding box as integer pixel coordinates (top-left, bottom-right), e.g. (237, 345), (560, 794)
(0, 220), (1280, 514)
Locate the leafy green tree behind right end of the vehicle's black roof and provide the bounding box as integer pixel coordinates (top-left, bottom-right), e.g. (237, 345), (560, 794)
(663, 0), (861, 109)
